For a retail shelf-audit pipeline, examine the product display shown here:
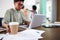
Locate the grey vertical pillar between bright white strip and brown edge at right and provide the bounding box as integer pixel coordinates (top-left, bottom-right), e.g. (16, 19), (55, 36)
(52, 0), (57, 21)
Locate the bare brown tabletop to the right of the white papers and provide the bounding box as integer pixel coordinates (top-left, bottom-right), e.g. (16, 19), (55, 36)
(0, 27), (60, 40)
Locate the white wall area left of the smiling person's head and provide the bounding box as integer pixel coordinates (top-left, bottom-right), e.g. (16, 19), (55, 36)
(0, 0), (13, 17)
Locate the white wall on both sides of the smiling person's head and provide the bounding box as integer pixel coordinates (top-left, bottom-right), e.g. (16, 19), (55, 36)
(0, 0), (39, 17)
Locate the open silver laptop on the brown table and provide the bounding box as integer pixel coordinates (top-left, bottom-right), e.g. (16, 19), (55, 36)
(20, 14), (45, 29)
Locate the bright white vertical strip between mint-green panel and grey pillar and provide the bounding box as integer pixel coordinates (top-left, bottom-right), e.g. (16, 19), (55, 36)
(46, 0), (52, 20)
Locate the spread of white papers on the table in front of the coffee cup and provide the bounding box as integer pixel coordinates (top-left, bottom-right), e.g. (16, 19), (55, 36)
(0, 29), (45, 40)
